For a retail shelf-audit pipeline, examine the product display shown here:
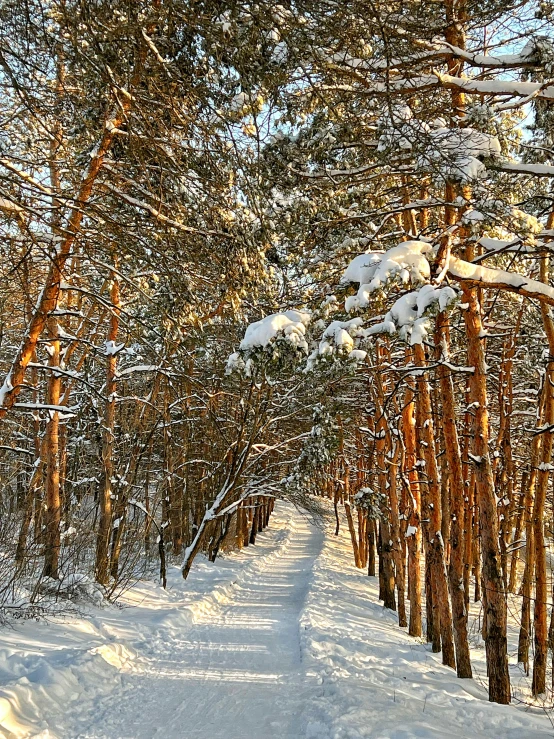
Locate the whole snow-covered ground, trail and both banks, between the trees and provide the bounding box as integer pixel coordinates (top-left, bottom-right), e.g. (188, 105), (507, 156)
(0, 503), (554, 739)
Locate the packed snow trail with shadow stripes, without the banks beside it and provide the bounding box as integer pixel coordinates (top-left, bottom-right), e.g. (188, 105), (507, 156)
(56, 508), (323, 739)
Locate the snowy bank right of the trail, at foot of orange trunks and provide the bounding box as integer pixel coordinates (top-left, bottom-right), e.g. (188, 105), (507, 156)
(301, 522), (554, 739)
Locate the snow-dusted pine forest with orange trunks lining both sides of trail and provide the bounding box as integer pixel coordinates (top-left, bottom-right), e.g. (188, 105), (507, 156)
(0, 0), (554, 739)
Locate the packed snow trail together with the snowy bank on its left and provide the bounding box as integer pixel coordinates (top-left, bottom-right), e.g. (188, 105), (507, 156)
(0, 505), (324, 739)
